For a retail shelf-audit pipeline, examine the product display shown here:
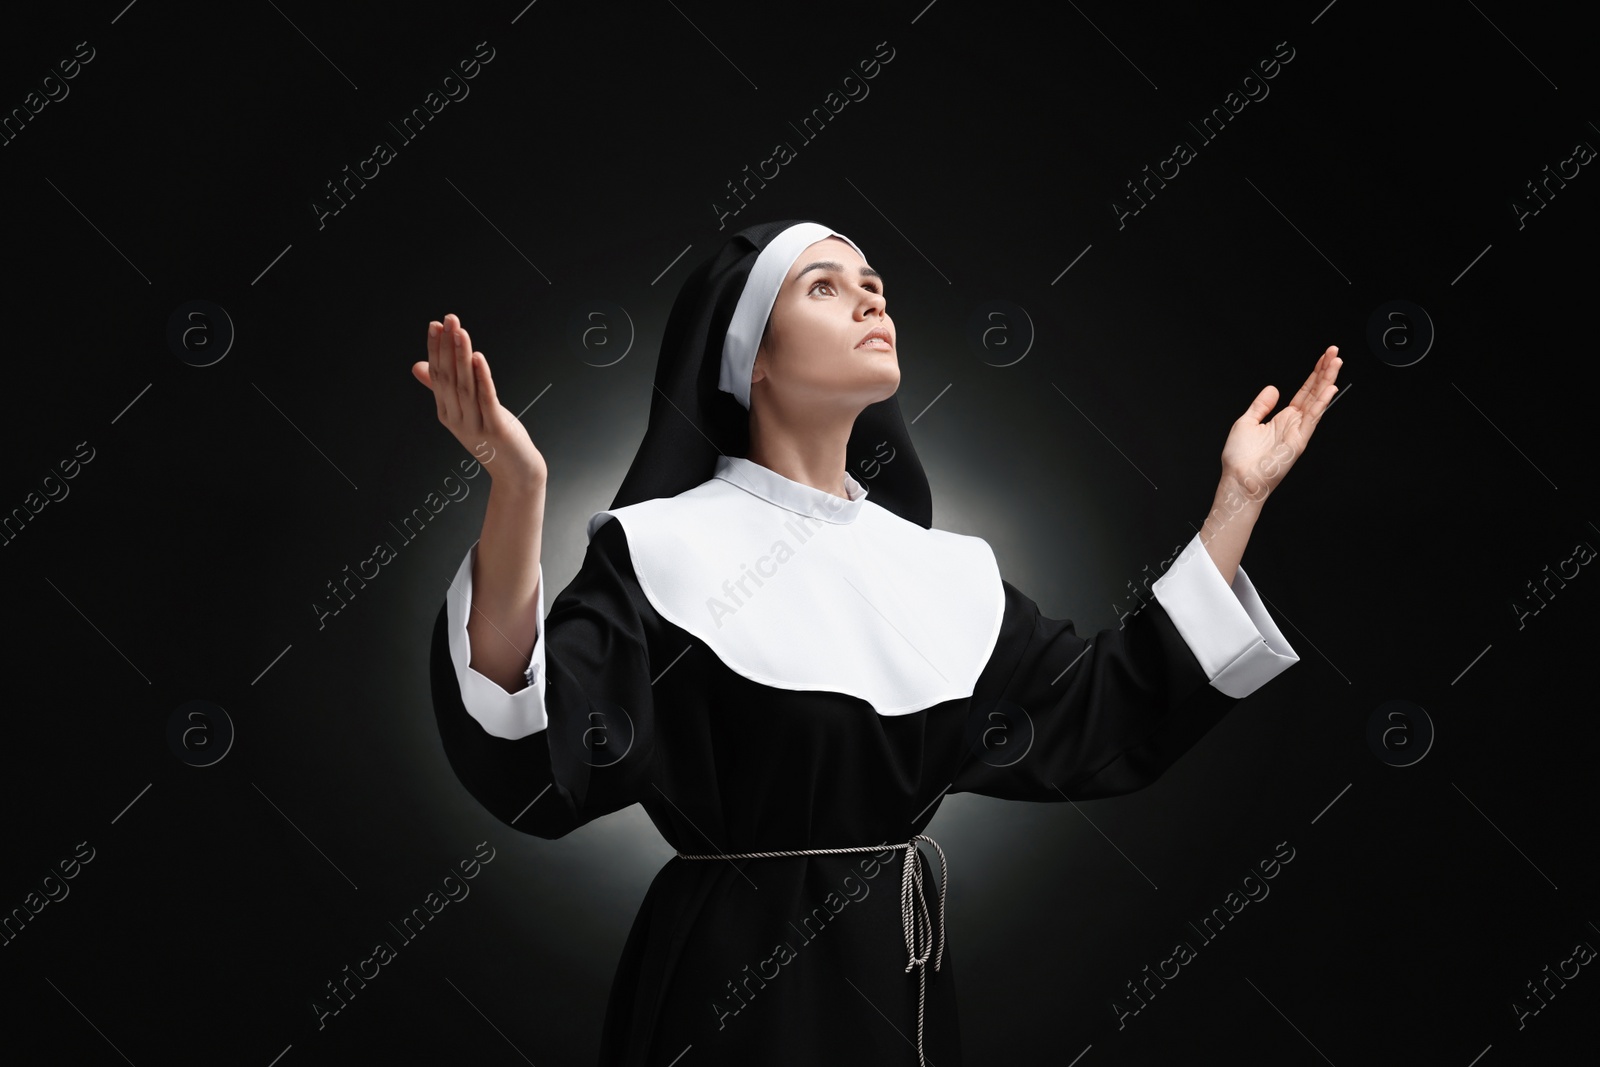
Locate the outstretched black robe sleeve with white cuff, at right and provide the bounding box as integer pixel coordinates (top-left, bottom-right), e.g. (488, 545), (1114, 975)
(949, 541), (1299, 801)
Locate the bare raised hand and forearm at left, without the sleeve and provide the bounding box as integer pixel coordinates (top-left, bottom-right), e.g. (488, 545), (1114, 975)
(411, 315), (549, 693)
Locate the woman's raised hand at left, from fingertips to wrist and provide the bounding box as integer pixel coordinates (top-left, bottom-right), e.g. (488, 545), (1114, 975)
(411, 315), (549, 488)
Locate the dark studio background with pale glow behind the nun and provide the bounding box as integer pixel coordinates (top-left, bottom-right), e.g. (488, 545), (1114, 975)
(0, 0), (1600, 1067)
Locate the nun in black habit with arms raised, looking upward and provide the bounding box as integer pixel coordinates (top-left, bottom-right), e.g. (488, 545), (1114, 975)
(413, 221), (1339, 1067)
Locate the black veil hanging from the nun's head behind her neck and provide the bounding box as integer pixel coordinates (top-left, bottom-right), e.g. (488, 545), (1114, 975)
(611, 219), (933, 530)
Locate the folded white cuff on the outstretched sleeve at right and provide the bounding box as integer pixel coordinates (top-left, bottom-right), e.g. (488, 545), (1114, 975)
(1150, 534), (1299, 699)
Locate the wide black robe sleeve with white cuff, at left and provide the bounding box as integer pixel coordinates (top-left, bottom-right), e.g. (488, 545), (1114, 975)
(430, 520), (654, 838)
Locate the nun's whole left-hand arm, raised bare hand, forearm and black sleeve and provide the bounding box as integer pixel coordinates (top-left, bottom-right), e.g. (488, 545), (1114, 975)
(411, 315), (656, 838)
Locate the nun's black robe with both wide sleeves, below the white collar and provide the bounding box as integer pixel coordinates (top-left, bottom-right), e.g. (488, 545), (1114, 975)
(432, 522), (1235, 1067)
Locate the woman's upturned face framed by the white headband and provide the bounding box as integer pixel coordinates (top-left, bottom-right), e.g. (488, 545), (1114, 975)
(750, 237), (899, 408)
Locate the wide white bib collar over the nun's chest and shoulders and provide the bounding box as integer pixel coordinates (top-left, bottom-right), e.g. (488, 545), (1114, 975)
(589, 456), (1005, 715)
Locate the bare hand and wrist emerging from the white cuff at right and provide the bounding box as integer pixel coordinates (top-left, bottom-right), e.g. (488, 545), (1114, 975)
(1200, 346), (1344, 585)
